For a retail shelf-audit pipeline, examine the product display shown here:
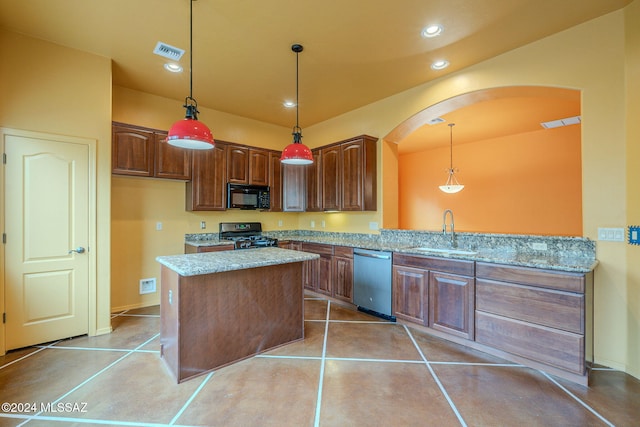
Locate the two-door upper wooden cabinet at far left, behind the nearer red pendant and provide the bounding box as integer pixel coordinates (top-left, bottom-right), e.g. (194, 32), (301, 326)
(111, 122), (191, 181)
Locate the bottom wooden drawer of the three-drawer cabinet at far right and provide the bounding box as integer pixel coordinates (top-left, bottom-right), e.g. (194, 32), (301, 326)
(476, 311), (585, 375)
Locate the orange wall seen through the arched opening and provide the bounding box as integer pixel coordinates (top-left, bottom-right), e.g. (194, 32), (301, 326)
(398, 125), (584, 236)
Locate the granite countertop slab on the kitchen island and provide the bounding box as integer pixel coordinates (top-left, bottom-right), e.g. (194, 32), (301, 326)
(156, 248), (320, 276)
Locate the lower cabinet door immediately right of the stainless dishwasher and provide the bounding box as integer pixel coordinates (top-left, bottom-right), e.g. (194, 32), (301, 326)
(393, 265), (429, 326)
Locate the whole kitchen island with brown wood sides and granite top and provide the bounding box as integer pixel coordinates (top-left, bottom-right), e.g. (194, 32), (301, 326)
(156, 248), (319, 383)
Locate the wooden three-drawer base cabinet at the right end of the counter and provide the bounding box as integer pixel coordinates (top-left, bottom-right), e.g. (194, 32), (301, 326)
(475, 262), (593, 377)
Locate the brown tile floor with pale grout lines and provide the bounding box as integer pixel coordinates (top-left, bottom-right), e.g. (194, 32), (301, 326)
(0, 297), (640, 427)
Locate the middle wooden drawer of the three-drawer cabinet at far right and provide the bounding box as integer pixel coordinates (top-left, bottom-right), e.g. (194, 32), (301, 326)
(476, 279), (584, 334)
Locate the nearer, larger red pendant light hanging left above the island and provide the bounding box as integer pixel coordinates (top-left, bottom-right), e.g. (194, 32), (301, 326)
(167, 0), (215, 150)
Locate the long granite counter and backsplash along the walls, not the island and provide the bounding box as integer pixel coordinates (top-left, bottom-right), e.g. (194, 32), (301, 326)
(185, 230), (598, 273)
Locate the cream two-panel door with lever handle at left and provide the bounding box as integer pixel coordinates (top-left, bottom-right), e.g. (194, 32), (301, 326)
(3, 131), (91, 350)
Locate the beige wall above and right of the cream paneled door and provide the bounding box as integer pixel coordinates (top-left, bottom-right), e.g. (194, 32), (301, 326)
(0, 29), (111, 347)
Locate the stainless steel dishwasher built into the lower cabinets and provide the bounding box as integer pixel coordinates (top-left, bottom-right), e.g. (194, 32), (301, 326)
(353, 248), (396, 322)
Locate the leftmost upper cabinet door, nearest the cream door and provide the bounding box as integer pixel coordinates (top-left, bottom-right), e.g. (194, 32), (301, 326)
(111, 124), (155, 176)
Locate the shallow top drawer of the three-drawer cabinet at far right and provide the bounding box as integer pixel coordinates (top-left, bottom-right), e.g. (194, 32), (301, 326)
(476, 262), (585, 293)
